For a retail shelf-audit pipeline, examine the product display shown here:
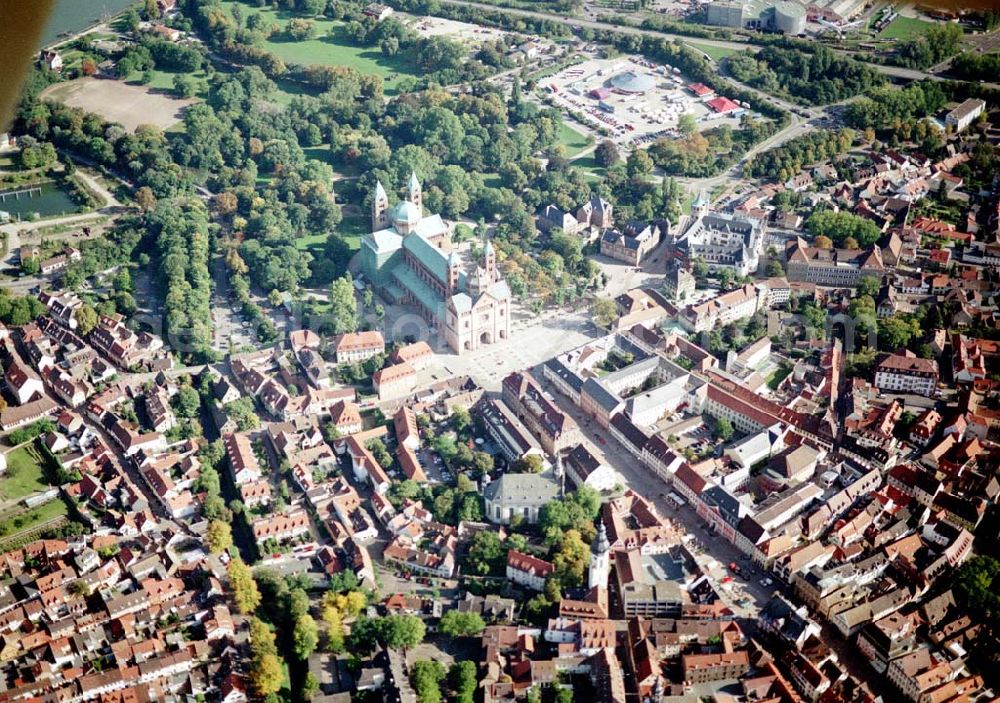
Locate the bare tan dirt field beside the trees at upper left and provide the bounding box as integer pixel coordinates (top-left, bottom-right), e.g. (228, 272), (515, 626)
(42, 78), (197, 132)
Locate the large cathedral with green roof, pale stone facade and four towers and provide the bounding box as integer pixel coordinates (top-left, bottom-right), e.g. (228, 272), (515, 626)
(361, 175), (511, 354)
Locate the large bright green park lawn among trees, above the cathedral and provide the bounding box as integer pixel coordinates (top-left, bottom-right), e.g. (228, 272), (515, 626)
(222, 0), (417, 99)
